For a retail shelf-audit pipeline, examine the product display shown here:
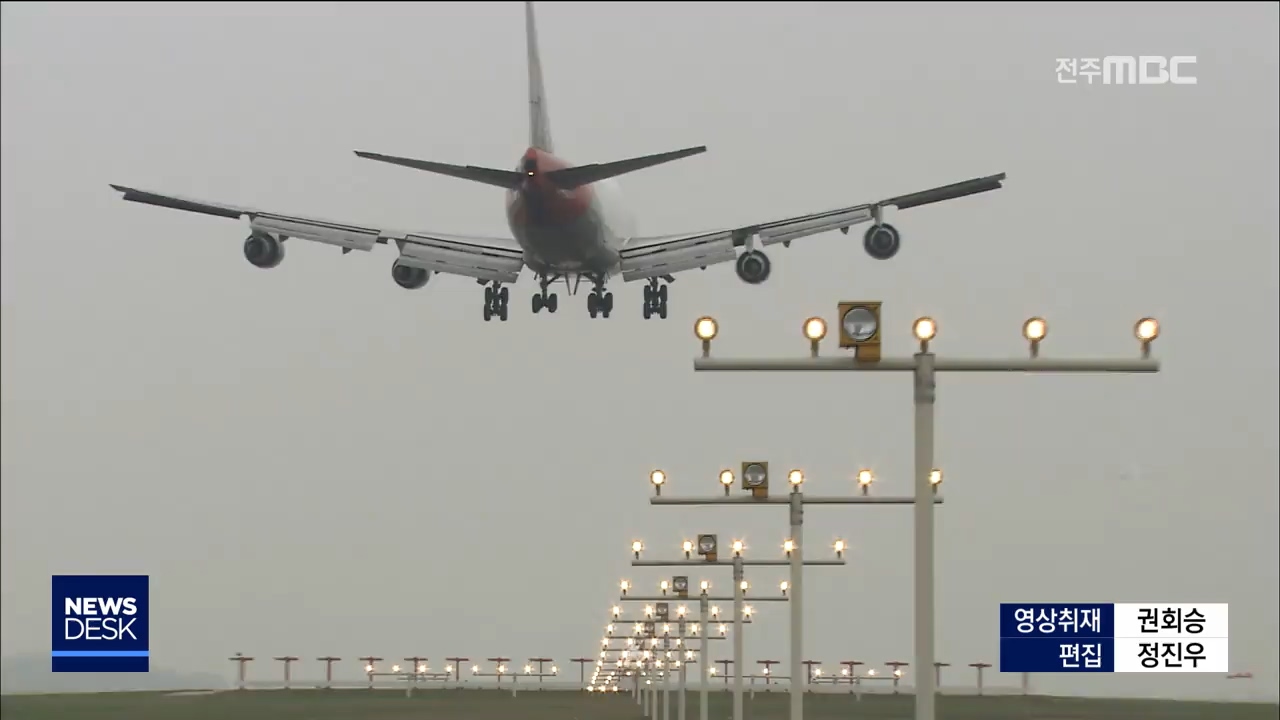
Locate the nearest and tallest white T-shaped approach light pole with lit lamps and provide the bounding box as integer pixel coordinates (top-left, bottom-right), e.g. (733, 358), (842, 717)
(694, 308), (1160, 720)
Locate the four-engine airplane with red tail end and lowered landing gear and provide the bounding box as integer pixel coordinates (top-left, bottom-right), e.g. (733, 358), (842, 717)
(111, 3), (1005, 322)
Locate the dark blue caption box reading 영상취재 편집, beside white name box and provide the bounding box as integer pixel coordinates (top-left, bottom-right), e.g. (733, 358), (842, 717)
(1000, 602), (1115, 673)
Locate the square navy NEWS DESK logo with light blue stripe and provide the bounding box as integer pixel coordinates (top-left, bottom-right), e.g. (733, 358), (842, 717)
(50, 575), (151, 673)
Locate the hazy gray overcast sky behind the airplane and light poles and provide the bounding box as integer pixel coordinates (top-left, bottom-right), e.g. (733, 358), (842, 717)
(0, 3), (1280, 697)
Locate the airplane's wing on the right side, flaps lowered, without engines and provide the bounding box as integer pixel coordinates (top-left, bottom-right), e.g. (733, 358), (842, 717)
(621, 173), (1005, 282)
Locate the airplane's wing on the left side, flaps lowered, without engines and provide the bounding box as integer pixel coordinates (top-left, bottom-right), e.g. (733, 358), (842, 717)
(111, 184), (525, 283)
